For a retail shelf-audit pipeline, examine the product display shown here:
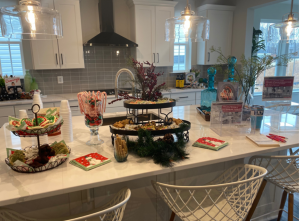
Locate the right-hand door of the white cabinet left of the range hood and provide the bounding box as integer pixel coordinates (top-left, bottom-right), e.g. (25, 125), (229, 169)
(54, 0), (84, 69)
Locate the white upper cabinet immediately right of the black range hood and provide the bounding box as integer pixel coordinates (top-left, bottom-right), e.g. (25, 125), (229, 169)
(127, 0), (177, 67)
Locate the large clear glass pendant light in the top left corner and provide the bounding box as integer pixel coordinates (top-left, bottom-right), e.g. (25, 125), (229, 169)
(0, 0), (63, 40)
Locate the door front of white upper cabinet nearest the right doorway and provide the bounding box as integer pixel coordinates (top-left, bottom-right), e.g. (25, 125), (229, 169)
(206, 10), (233, 64)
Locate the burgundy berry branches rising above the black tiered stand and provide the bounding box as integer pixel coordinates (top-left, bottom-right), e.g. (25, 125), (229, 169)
(109, 58), (167, 104)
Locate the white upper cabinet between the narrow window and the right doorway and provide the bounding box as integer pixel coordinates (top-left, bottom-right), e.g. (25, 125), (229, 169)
(197, 4), (235, 65)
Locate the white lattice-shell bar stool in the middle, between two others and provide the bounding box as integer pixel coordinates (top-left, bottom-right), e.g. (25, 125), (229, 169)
(152, 165), (267, 221)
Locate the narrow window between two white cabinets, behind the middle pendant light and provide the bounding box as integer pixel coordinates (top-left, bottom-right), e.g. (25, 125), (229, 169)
(173, 24), (191, 72)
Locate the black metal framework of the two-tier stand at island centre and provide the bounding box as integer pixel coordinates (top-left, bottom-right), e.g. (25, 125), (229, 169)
(110, 101), (191, 145)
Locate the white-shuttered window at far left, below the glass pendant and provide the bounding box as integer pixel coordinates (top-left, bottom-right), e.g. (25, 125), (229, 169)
(0, 17), (25, 77)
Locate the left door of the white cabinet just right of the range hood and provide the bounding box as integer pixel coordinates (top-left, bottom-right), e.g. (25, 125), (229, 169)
(135, 5), (156, 63)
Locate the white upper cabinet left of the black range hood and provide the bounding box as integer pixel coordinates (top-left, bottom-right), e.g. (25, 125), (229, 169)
(23, 0), (84, 70)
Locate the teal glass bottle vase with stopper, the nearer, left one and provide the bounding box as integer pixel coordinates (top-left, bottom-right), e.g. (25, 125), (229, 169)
(201, 67), (217, 111)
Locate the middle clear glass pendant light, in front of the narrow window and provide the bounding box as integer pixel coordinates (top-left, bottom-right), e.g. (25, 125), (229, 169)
(165, 0), (209, 42)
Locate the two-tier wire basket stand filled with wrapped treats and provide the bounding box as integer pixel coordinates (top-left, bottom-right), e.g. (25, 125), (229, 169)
(5, 104), (71, 173)
